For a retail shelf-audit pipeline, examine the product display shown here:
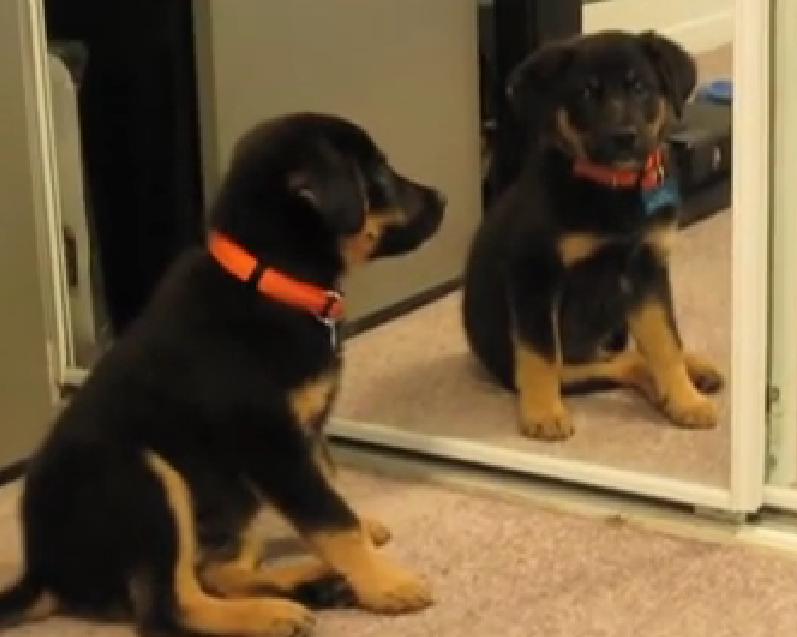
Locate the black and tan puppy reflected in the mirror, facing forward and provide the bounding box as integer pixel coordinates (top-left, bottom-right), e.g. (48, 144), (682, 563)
(463, 32), (722, 439)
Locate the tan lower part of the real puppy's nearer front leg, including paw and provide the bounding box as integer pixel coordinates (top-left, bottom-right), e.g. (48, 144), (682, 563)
(307, 529), (432, 614)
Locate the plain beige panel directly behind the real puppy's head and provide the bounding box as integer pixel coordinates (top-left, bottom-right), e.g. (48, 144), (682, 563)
(196, 0), (481, 318)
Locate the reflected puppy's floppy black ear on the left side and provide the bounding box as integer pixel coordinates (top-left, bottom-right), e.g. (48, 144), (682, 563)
(506, 41), (573, 123)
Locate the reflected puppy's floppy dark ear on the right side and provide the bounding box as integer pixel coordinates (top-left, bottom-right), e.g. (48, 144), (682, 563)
(639, 31), (697, 117)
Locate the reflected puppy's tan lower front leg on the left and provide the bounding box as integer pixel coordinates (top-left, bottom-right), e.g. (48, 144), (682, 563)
(515, 339), (574, 440)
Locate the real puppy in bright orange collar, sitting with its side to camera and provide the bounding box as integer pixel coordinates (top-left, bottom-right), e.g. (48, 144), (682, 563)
(0, 114), (444, 637)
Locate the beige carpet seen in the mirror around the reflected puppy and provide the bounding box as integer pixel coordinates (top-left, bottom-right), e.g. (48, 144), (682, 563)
(336, 47), (732, 486)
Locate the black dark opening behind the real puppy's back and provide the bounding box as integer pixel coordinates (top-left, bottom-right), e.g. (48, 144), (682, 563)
(45, 0), (203, 335)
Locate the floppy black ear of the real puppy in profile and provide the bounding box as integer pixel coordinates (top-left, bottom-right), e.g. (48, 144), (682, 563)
(286, 142), (368, 234)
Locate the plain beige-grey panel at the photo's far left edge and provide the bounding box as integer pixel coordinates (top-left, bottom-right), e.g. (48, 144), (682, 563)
(0, 0), (58, 466)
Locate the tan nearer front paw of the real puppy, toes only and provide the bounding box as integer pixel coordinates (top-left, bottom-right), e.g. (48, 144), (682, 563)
(352, 560), (432, 615)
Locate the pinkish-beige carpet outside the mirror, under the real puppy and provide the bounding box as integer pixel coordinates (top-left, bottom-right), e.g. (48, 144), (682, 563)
(0, 472), (797, 637)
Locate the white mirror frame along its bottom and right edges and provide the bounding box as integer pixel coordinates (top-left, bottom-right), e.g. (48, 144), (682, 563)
(330, 0), (770, 512)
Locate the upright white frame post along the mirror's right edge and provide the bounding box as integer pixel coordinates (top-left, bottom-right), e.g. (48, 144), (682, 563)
(730, 0), (771, 511)
